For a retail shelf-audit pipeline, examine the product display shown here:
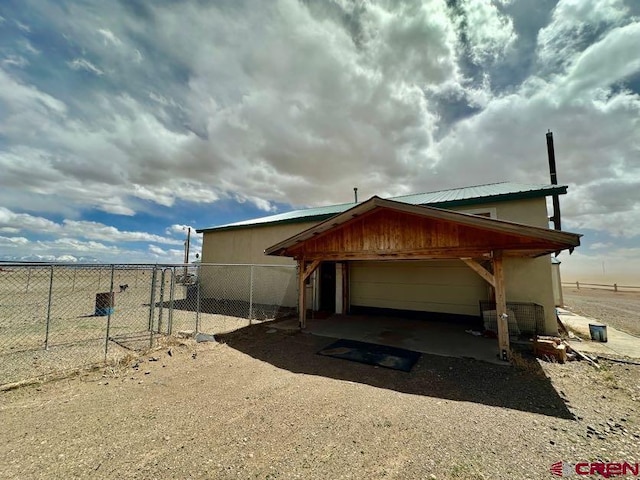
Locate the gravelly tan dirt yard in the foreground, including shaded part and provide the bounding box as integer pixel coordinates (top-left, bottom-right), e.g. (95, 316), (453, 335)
(0, 324), (640, 480)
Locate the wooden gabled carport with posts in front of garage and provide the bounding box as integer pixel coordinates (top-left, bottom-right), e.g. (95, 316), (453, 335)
(265, 197), (580, 360)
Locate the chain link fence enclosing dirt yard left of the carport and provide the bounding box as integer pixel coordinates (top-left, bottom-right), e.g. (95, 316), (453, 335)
(0, 263), (297, 385)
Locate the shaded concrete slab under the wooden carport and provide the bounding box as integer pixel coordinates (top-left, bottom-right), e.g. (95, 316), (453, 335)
(273, 315), (509, 365)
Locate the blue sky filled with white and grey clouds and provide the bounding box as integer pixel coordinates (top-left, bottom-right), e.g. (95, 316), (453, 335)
(0, 0), (640, 284)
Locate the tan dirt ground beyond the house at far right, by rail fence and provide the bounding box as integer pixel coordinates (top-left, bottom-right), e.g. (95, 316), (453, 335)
(562, 287), (640, 336)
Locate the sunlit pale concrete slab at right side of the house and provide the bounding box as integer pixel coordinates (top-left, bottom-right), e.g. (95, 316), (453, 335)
(558, 308), (640, 359)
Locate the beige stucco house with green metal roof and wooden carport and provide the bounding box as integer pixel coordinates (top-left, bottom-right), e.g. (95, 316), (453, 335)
(198, 182), (580, 354)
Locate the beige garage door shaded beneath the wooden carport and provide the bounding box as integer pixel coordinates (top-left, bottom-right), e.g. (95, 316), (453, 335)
(349, 260), (489, 315)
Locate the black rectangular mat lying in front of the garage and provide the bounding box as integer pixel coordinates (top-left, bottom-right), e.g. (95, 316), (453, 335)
(318, 339), (422, 372)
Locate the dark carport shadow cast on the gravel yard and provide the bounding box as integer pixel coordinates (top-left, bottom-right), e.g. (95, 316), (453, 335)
(216, 324), (575, 420)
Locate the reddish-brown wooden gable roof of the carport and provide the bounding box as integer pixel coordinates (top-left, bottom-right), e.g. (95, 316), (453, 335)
(265, 196), (581, 260)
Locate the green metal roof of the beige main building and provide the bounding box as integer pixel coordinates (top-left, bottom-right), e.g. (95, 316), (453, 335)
(196, 182), (567, 233)
